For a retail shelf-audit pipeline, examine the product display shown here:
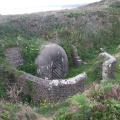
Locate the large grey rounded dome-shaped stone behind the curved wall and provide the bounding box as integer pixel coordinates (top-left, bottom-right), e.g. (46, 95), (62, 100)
(35, 43), (68, 80)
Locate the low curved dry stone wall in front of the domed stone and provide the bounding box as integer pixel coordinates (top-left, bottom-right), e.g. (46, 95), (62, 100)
(18, 73), (87, 102)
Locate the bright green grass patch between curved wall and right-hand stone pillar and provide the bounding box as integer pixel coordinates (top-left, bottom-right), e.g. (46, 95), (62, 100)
(67, 56), (101, 84)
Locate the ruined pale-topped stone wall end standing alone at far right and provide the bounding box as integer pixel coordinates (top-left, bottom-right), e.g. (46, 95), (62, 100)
(99, 52), (116, 80)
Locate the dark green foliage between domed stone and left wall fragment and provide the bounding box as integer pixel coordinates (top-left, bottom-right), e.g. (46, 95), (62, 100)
(19, 38), (42, 75)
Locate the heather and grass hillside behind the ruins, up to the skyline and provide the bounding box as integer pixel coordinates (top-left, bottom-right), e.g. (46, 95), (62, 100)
(0, 2), (120, 77)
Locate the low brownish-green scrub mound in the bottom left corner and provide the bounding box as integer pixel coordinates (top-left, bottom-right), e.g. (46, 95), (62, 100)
(0, 101), (38, 120)
